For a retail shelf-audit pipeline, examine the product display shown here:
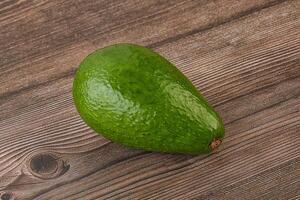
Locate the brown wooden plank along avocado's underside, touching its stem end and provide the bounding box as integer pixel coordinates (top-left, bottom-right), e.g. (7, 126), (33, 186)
(25, 80), (300, 199)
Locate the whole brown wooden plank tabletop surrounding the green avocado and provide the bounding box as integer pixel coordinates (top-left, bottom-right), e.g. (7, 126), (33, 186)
(0, 0), (300, 200)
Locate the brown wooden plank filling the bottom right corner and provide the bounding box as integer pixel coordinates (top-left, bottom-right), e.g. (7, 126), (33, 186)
(197, 158), (300, 200)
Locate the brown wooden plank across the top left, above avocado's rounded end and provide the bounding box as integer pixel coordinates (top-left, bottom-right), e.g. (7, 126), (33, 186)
(0, 0), (290, 99)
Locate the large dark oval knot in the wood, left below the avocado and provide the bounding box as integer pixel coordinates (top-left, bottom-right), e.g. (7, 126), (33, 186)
(27, 153), (70, 179)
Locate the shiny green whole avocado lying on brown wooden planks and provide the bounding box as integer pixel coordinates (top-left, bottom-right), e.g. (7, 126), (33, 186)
(73, 44), (224, 154)
